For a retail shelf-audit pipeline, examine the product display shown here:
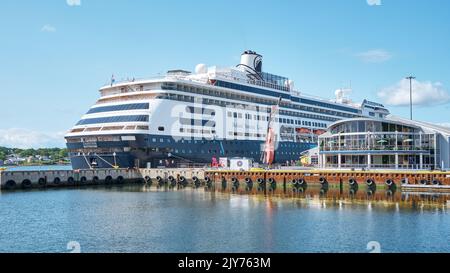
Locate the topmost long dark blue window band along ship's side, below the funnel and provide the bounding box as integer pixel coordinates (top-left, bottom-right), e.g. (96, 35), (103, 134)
(161, 83), (359, 117)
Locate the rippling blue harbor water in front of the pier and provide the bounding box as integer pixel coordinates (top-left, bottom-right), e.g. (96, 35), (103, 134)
(0, 185), (450, 252)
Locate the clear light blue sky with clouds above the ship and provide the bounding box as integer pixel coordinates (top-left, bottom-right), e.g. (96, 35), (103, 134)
(0, 0), (450, 147)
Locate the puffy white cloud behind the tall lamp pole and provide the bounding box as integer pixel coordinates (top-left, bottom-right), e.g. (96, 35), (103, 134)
(378, 79), (450, 106)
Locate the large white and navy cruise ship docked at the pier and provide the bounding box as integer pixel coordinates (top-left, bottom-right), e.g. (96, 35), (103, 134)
(65, 50), (389, 169)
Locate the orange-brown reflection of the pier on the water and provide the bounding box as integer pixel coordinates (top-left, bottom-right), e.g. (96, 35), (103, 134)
(135, 181), (450, 209)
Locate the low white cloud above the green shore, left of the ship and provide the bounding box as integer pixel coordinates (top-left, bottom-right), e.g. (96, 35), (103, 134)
(0, 128), (65, 149)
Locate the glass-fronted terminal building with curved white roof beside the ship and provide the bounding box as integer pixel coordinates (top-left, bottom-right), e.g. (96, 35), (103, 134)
(318, 115), (450, 170)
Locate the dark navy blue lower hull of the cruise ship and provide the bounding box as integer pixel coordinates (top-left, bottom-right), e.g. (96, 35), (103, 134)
(67, 135), (317, 169)
